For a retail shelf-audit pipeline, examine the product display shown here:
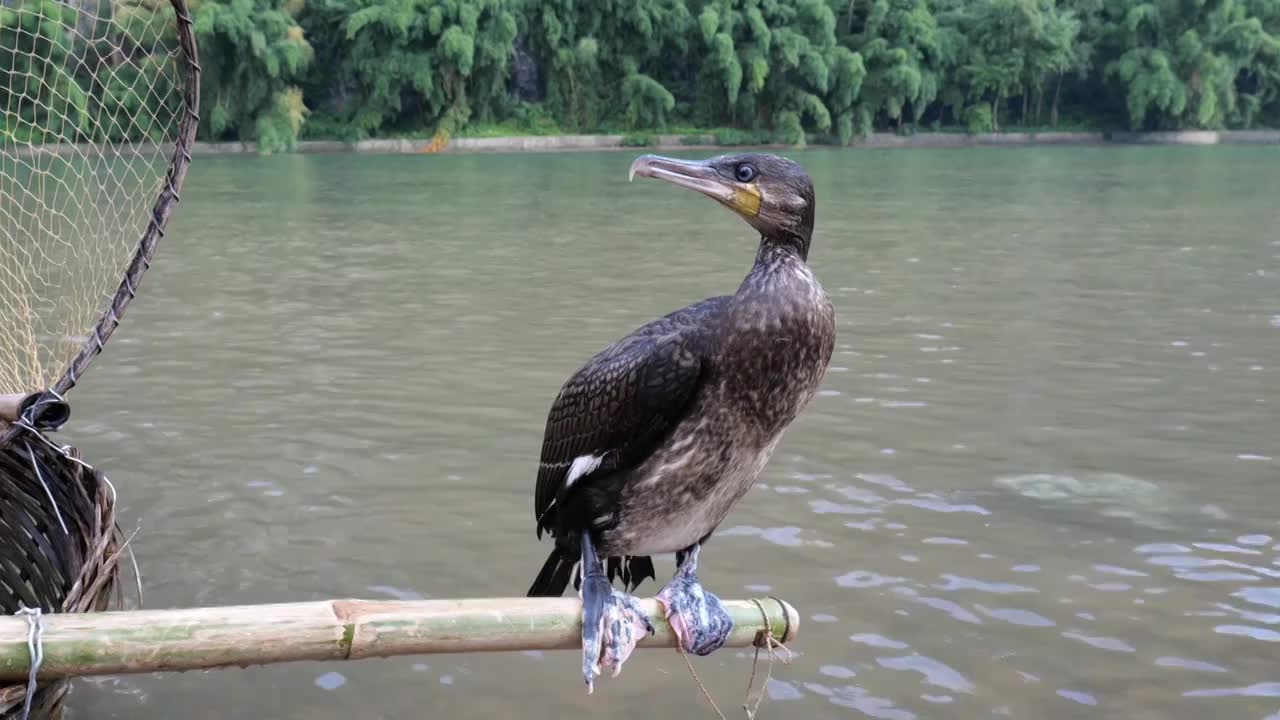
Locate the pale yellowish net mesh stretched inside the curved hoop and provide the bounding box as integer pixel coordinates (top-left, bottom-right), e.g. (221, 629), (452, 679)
(0, 0), (196, 395)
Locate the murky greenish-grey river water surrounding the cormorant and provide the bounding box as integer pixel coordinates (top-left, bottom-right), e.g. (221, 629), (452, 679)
(60, 147), (1280, 720)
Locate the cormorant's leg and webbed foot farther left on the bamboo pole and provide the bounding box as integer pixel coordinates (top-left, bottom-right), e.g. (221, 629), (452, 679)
(581, 532), (653, 693)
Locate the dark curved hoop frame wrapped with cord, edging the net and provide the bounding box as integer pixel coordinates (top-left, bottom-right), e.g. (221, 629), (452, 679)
(0, 0), (200, 448)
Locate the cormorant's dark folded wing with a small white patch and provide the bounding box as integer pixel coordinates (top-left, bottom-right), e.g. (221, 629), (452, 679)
(534, 296), (728, 537)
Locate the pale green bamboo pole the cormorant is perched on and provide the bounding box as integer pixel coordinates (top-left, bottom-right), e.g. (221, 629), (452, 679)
(0, 597), (800, 684)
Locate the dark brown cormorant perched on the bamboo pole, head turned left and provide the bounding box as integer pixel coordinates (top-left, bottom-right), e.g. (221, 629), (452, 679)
(529, 152), (836, 692)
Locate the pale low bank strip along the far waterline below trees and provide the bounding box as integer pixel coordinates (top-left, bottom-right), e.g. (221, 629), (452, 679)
(192, 129), (1280, 155)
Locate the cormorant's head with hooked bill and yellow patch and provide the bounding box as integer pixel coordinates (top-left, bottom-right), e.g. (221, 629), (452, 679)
(630, 152), (814, 258)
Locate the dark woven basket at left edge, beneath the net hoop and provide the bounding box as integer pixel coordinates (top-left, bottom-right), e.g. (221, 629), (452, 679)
(0, 422), (123, 720)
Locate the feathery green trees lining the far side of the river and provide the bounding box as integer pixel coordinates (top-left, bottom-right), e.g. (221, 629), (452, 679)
(0, 0), (1280, 151)
